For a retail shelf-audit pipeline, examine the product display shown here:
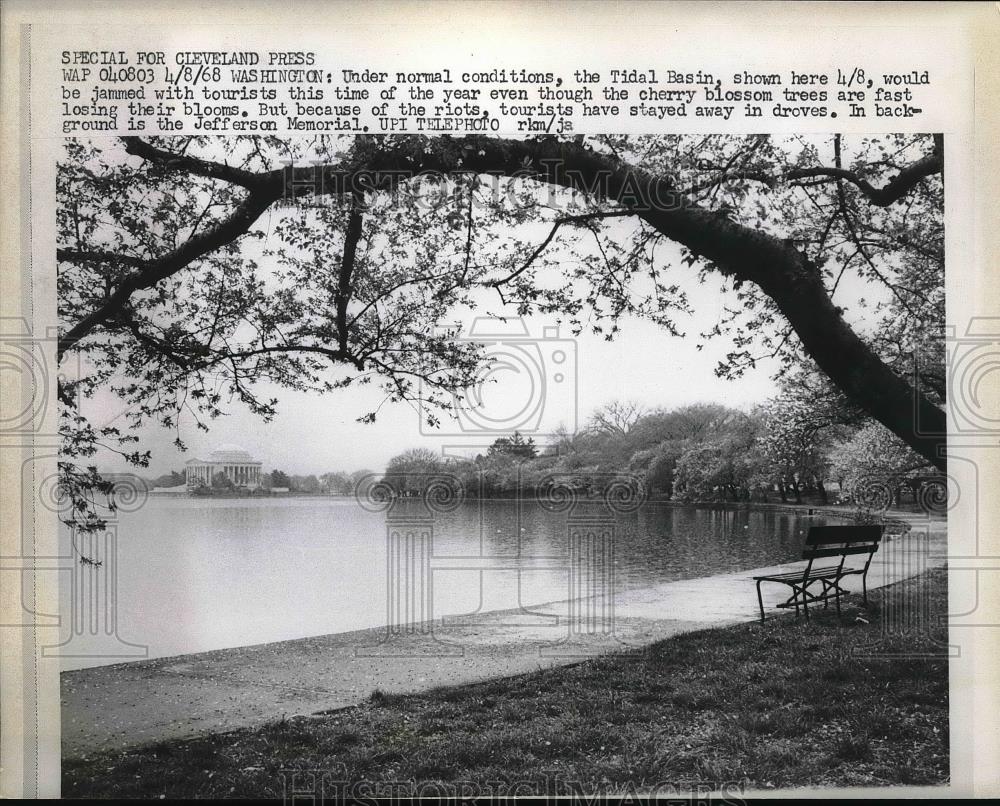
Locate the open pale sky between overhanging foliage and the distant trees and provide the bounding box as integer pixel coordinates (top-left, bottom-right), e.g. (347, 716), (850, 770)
(88, 269), (776, 475)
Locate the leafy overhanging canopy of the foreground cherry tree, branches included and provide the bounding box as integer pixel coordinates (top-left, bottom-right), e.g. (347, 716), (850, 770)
(57, 135), (945, 529)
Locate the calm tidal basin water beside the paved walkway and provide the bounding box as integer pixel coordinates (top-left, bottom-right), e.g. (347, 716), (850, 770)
(52, 495), (836, 669)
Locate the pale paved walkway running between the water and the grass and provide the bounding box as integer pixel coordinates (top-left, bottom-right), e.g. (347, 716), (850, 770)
(62, 519), (947, 758)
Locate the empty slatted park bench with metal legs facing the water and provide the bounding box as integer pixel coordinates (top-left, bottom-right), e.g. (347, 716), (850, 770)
(754, 526), (884, 623)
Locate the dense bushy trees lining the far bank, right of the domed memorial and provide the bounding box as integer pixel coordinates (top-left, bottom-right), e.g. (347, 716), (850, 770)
(382, 364), (940, 505)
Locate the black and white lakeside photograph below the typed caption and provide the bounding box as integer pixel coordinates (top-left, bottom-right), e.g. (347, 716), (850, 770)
(48, 129), (952, 802)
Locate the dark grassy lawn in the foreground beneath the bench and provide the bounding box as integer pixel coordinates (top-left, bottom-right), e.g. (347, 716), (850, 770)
(63, 570), (948, 798)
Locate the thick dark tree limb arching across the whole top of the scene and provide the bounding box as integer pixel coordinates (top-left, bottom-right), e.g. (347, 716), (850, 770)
(60, 136), (946, 469)
